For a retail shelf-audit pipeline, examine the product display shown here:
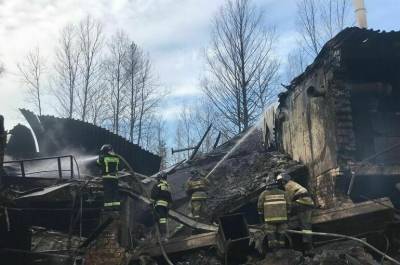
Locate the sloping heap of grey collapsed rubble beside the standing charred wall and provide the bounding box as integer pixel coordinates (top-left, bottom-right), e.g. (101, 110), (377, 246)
(169, 129), (307, 221)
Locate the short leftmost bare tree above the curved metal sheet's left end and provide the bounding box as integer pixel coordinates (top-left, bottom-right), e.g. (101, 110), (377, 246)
(17, 48), (45, 115)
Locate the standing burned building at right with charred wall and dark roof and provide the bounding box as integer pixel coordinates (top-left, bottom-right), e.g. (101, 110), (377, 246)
(275, 28), (400, 208)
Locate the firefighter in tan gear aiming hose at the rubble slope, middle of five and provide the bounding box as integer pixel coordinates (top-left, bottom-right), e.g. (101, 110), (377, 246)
(186, 170), (208, 219)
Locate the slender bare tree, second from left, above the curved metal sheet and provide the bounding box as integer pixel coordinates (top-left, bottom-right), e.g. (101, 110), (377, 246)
(53, 24), (81, 118)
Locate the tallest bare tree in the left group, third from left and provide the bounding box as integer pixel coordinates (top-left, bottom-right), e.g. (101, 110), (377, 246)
(78, 16), (103, 121)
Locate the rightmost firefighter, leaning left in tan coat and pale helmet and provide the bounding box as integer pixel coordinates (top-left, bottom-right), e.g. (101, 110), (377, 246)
(276, 173), (314, 252)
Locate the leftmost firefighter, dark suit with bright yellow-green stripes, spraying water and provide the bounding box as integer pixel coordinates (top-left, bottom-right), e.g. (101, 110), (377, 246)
(97, 144), (121, 211)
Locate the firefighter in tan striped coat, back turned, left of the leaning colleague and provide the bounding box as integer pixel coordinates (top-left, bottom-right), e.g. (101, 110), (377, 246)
(257, 176), (288, 249)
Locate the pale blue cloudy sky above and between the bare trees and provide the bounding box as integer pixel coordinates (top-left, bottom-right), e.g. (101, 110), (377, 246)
(0, 0), (400, 128)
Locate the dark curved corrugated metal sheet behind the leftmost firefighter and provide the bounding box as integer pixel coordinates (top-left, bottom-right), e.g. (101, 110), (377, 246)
(20, 109), (161, 175)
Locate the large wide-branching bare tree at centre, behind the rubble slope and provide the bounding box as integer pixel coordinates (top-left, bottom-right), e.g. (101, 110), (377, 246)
(202, 0), (279, 134)
